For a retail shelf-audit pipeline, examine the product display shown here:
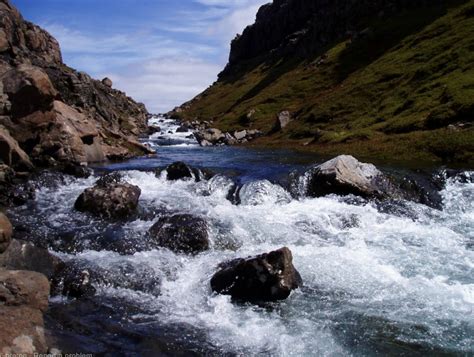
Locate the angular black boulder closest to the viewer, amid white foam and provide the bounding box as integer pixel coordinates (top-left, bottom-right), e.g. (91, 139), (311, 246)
(211, 247), (302, 302)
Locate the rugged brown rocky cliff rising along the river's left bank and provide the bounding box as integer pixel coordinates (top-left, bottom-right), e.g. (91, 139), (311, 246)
(0, 0), (149, 170)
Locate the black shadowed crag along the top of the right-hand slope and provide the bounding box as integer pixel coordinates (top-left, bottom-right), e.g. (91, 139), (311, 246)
(221, 0), (440, 75)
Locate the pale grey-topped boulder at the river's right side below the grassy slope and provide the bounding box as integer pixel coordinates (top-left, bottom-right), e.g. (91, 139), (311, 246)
(304, 155), (395, 198)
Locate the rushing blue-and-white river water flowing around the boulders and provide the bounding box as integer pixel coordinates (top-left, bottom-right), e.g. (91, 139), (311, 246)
(7, 118), (474, 356)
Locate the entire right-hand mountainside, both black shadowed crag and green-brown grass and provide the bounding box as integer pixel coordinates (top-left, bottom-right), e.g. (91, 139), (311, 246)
(172, 0), (474, 163)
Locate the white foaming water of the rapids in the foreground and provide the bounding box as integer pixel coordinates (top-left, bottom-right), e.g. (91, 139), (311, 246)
(11, 165), (474, 356)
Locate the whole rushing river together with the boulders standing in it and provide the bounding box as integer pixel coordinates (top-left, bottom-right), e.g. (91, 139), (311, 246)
(0, 117), (474, 356)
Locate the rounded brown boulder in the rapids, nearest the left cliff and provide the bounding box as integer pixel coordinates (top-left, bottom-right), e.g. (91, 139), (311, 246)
(74, 183), (141, 219)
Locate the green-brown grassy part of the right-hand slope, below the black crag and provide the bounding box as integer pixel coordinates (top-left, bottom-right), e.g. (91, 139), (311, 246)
(180, 0), (474, 164)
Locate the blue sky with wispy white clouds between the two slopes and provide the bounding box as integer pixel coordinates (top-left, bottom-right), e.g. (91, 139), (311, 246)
(11, 0), (270, 113)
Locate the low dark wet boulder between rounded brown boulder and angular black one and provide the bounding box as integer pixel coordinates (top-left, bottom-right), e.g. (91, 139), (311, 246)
(148, 214), (209, 254)
